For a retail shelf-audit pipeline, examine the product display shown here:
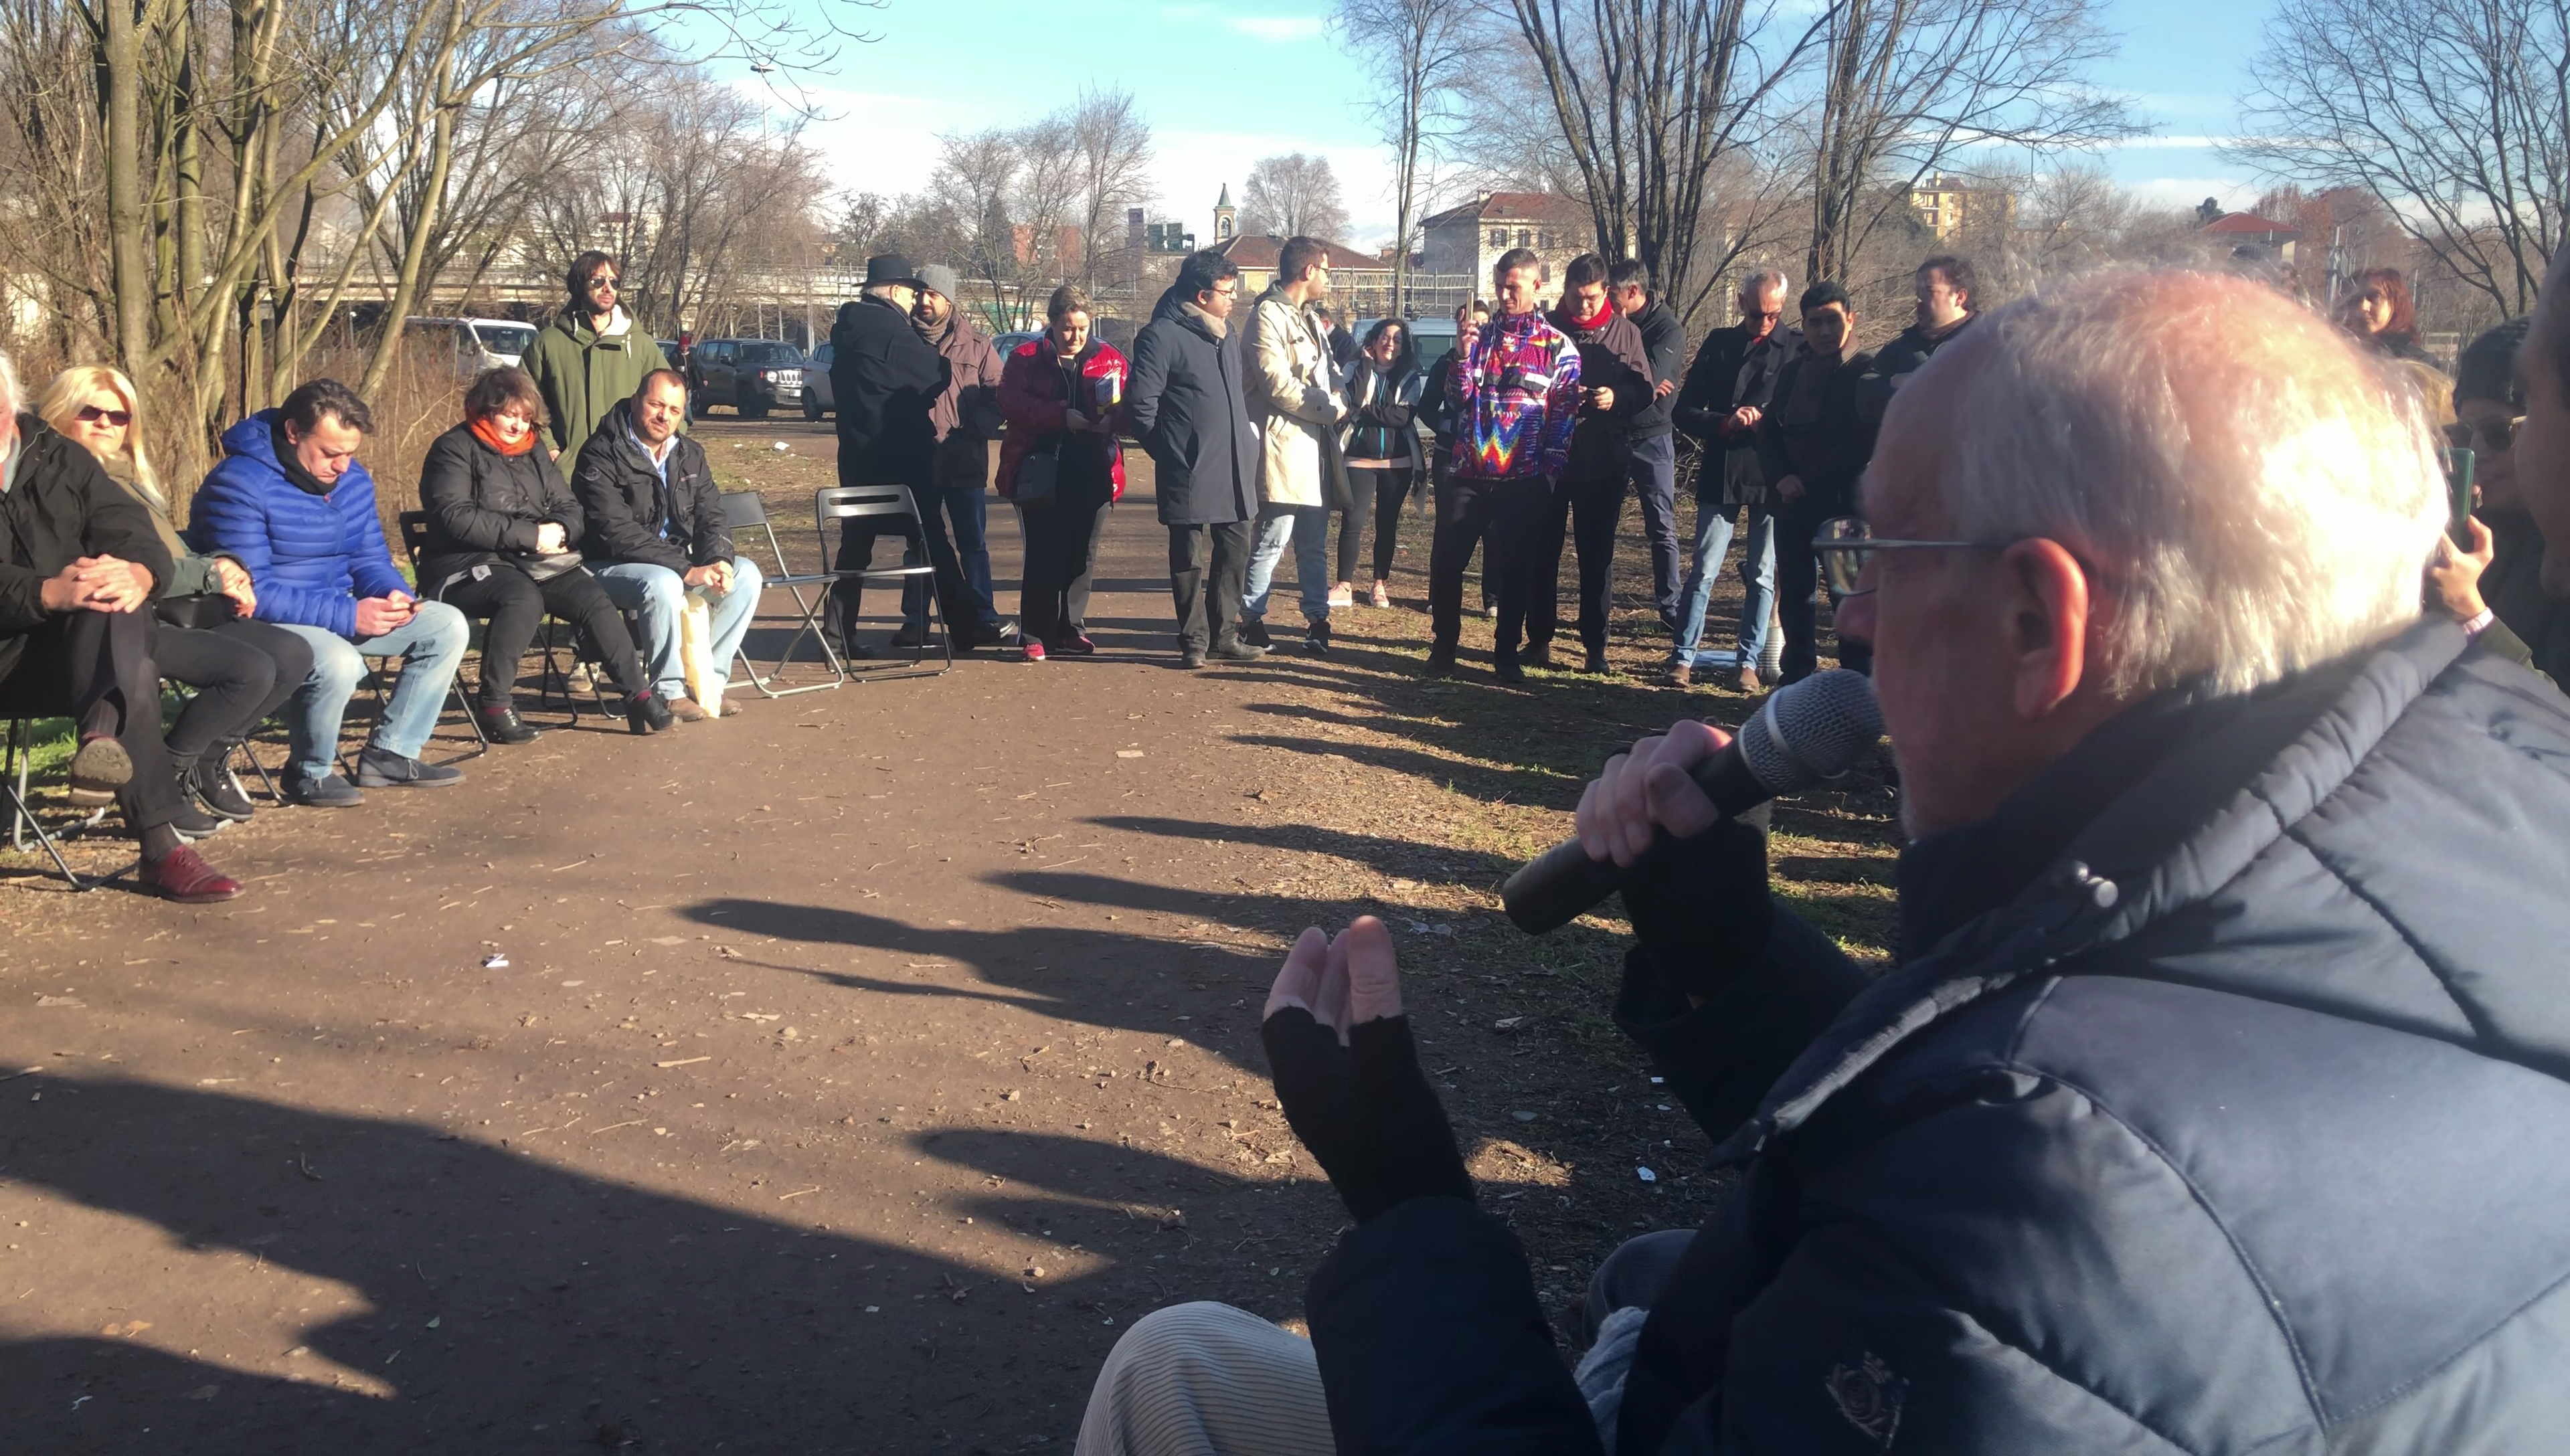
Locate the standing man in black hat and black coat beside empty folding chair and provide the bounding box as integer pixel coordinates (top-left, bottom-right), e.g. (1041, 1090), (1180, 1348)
(830, 252), (982, 657)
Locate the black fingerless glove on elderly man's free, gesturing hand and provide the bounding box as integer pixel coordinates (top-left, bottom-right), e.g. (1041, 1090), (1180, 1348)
(1260, 1006), (1472, 1222)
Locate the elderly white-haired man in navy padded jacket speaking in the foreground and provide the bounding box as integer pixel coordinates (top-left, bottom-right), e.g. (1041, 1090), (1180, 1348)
(1082, 275), (2570, 1456)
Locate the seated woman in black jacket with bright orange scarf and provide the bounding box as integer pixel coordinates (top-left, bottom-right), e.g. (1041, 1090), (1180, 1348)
(419, 367), (673, 742)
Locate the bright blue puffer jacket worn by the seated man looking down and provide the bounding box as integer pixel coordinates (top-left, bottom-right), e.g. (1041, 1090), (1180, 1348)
(187, 408), (411, 637)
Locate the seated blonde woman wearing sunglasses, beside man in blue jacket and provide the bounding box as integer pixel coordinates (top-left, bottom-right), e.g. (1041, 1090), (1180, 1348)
(36, 365), (313, 837)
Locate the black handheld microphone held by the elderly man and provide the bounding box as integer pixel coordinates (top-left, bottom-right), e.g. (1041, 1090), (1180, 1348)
(1498, 668), (1884, 935)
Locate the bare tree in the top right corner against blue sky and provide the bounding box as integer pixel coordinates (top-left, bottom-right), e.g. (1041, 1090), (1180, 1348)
(2228, 0), (2570, 313)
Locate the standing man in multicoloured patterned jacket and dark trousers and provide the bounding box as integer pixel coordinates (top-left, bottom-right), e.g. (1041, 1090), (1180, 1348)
(1429, 246), (1581, 683)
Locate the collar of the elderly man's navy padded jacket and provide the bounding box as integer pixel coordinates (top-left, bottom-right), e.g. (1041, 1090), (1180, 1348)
(1714, 622), (2467, 1166)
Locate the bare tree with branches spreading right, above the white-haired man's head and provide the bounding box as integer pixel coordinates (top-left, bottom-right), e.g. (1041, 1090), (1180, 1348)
(1804, 0), (2141, 280)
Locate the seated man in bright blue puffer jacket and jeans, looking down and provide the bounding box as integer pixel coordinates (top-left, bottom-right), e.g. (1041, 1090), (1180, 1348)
(187, 380), (470, 809)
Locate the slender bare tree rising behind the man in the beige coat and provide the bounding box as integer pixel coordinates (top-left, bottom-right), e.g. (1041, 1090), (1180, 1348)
(1331, 0), (1488, 318)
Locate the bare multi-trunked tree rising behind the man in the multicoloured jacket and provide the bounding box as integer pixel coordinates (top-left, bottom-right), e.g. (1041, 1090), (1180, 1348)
(1509, 0), (1861, 325)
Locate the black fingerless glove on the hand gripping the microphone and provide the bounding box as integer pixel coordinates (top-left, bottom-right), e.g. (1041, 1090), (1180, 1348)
(1624, 804), (1776, 996)
